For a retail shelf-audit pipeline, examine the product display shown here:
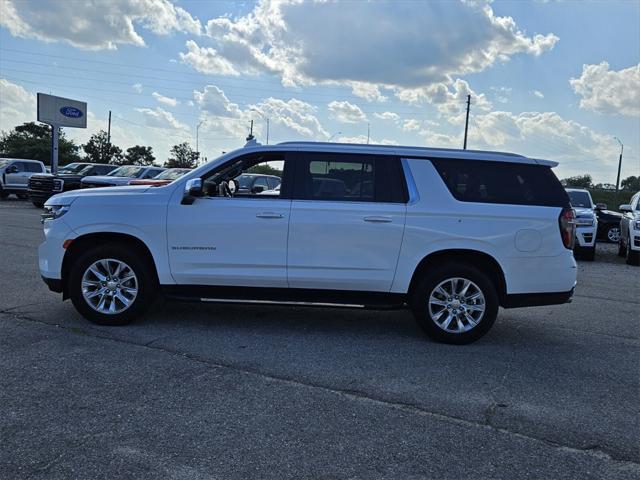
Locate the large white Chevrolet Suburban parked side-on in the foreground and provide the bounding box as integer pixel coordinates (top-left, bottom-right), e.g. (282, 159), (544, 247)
(39, 142), (577, 343)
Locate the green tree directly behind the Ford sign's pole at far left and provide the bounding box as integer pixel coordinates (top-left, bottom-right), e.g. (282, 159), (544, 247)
(0, 122), (80, 165)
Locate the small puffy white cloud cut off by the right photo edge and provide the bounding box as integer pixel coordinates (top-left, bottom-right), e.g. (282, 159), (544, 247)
(569, 62), (640, 116)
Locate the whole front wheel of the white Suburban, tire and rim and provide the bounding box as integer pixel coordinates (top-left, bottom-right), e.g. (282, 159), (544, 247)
(69, 244), (156, 325)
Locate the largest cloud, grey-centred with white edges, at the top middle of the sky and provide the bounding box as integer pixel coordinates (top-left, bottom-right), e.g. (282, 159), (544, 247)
(181, 0), (558, 96)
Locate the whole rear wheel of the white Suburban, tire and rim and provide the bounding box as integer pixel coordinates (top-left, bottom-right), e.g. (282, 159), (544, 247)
(410, 263), (498, 345)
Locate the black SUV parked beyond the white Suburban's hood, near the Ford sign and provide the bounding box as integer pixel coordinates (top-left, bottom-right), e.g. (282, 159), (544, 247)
(27, 163), (118, 208)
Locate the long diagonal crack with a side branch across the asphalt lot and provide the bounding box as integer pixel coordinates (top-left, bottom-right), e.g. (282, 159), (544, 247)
(5, 313), (640, 473)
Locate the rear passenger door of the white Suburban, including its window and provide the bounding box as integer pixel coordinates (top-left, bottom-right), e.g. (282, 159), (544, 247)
(287, 153), (407, 292)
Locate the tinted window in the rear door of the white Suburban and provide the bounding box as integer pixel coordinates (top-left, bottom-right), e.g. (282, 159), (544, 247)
(294, 153), (406, 203)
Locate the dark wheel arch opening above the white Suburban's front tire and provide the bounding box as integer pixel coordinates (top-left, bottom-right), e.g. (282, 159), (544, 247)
(61, 232), (159, 299)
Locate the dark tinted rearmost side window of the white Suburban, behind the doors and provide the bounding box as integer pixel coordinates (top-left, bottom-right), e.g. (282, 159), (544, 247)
(431, 158), (569, 207)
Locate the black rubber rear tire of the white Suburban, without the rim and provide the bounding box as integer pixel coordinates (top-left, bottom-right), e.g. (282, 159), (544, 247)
(409, 262), (499, 345)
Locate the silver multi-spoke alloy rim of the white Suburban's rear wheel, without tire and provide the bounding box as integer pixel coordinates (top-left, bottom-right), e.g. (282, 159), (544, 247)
(429, 277), (486, 333)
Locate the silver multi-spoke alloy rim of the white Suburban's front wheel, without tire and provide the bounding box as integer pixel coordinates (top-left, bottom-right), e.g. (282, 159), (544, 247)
(82, 258), (138, 315)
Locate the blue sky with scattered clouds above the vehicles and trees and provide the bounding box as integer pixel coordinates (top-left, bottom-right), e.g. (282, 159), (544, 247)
(0, 0), (640, 183)
